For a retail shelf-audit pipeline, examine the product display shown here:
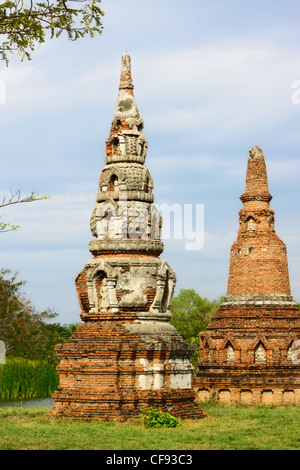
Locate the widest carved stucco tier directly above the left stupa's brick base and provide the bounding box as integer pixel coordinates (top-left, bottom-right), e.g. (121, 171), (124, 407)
(76, 255), (176, 321)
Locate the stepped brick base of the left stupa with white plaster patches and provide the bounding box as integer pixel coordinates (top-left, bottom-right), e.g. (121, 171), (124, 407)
(49, 319), (205, 420)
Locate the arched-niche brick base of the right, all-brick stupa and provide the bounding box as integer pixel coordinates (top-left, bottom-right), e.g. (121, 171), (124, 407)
(193, 300), (300, 405)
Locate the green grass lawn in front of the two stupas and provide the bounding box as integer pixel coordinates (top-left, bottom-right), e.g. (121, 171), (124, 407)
(0, 403), (300, 450)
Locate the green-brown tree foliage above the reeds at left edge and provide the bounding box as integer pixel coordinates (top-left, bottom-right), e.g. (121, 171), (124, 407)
(0, 269), (77, 363)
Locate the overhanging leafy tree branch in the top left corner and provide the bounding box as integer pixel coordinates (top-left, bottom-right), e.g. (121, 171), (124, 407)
(0, 0), (104, 64)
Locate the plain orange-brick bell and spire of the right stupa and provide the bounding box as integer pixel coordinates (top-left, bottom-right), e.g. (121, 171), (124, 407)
(227, 147), (290, 302)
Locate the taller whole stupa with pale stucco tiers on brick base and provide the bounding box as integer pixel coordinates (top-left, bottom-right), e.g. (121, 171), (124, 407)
(50, 53), (204, 420)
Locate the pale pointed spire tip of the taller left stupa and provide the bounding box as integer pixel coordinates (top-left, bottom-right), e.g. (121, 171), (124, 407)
(115, 52), (139, 118)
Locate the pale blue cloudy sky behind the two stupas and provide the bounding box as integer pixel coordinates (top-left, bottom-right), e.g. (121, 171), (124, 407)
(0, 0), (300, 323)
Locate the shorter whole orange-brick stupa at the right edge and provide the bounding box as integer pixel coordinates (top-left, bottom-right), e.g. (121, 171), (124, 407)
(195, 147), (300, 405)
